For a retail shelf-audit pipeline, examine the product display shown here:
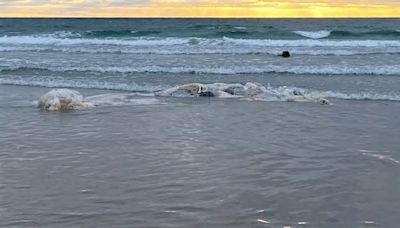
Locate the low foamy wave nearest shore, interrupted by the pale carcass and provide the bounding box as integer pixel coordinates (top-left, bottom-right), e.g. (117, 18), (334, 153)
(0, 77), (400, 101)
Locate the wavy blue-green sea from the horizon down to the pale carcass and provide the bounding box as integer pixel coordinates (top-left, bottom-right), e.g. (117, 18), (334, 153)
(0, 19), (400, 100)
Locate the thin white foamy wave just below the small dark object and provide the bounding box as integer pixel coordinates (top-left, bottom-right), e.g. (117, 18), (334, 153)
(0, 63), (400, 75)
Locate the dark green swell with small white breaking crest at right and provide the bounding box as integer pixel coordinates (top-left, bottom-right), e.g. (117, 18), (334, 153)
(3, 29), (400, 39)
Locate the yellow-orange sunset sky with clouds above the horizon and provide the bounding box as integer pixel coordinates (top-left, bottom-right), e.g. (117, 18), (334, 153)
(0, 0), (400, 18)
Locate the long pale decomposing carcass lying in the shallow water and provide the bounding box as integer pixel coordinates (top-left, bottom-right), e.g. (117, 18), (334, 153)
(38, 82), (330, 111)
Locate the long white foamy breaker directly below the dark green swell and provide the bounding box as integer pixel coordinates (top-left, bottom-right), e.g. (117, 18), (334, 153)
(0, 36), (400, 48)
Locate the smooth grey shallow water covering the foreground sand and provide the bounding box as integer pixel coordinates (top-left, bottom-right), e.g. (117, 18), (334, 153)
(0, 86), (400, 227)
